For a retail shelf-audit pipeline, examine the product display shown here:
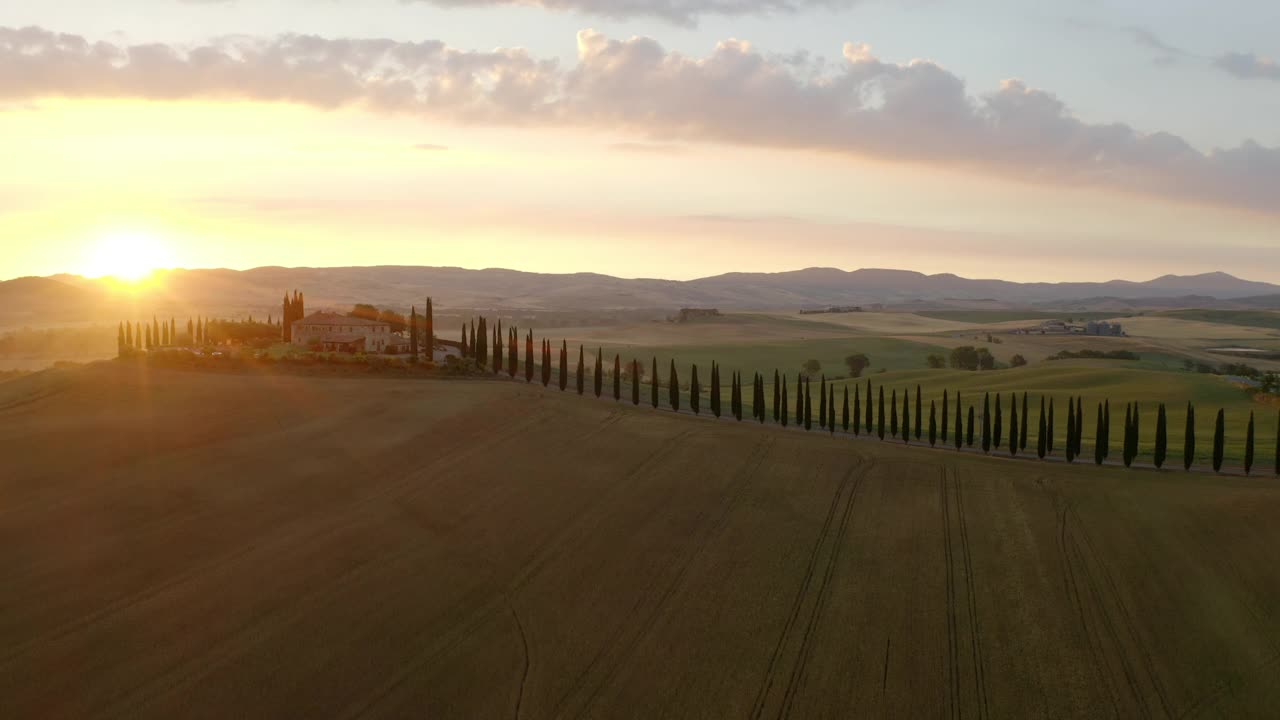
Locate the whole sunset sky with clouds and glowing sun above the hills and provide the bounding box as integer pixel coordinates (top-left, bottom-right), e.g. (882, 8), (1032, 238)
(0, 0), (1280, 282)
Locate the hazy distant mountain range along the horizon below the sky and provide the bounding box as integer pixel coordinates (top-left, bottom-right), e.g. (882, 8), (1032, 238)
(0, 265), (1280, 325)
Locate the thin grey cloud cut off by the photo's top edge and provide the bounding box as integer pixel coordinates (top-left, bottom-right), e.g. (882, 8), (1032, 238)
(407, 0), (859, 26)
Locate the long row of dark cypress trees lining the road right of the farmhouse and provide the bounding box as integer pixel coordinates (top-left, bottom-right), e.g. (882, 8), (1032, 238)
(445, 318), (1280, 475)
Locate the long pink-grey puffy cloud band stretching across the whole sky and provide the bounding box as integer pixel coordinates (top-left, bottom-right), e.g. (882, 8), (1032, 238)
(0, 28), (1280, 213)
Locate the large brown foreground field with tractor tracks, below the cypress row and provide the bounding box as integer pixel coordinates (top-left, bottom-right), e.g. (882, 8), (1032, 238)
(0, 364), (1280, 719)
